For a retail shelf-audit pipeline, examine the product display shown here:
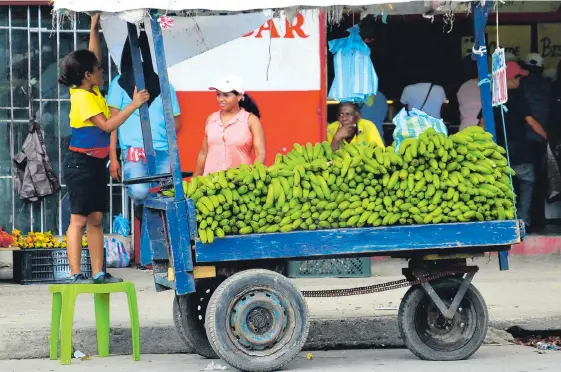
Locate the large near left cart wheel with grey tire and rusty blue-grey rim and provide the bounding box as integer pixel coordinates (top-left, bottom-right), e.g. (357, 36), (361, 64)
(206, 269), (310, 372)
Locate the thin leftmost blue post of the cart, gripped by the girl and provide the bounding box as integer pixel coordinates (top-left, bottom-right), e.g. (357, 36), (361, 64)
(127, 23), (156, 176)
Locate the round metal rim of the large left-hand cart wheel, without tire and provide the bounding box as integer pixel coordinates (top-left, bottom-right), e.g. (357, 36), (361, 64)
(229, 290), (288, 351)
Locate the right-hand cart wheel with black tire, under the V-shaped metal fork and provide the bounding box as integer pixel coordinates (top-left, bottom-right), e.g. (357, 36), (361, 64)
(398, 278), (489, 361)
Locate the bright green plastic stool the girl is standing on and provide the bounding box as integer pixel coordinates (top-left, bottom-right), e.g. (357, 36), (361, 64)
(49, 282), (140, 364)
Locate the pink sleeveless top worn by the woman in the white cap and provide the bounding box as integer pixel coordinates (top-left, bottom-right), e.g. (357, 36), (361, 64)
(204, 109), (253, 175)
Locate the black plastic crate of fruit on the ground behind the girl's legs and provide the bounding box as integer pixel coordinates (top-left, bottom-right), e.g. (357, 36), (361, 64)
(13, 248), (92, 284)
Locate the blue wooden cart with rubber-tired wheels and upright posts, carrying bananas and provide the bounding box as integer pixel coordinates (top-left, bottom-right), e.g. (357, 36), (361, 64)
(53, 1), (524, 371)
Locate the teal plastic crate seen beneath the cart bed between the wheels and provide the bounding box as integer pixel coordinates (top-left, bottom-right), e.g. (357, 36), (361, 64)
(288, 257), (372, 278)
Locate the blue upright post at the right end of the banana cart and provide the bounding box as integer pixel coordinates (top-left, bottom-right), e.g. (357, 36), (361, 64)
(472, 1), (498, 142)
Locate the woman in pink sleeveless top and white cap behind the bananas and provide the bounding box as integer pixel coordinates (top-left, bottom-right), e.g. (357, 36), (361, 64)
(193, 75), (265, 176)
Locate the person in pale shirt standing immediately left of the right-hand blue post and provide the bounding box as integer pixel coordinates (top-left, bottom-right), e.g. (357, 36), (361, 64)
(456, 56), (481, 130)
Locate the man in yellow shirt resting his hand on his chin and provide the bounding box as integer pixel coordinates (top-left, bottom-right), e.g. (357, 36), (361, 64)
(327, 102), (384, 151)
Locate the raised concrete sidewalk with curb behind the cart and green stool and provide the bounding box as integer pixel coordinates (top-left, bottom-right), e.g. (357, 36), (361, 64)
(0, 255), (561, 359)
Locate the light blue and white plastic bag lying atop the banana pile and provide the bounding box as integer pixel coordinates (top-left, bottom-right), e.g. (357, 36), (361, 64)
(393, 108), (448, 151)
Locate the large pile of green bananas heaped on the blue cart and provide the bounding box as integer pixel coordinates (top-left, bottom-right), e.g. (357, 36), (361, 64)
(178, 126), (515, 243)
